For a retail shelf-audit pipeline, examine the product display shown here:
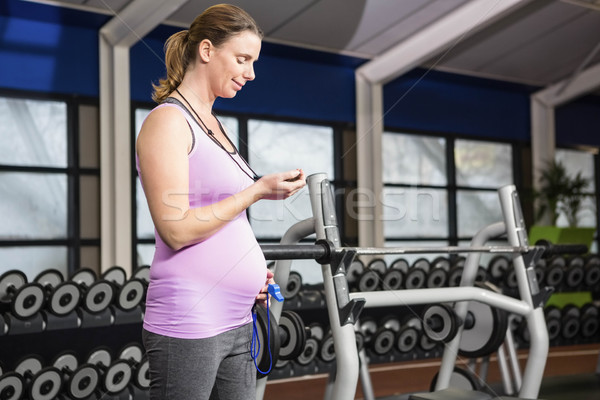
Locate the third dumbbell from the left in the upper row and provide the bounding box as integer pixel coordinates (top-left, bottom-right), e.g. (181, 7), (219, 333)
(69, 268), (115, 314)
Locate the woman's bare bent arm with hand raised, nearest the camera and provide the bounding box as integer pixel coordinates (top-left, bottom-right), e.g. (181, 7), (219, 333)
(136, 107), (306, 250)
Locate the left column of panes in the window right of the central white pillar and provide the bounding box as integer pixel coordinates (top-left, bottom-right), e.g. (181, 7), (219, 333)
(382, 132), (449, 265)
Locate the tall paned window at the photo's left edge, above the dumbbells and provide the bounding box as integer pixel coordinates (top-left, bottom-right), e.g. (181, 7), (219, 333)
(0, 97), (72, 280)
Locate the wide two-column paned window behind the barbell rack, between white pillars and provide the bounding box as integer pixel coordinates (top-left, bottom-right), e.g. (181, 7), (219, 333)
(382, 132), (513, 262)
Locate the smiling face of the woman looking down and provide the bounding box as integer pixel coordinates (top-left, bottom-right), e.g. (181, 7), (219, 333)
(208, 31), (261, 98)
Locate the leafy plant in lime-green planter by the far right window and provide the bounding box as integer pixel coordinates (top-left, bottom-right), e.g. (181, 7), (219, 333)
(529, 161), (596, 247)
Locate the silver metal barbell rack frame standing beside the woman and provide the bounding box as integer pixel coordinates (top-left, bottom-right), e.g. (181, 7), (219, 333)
(257, 174), (549, 400)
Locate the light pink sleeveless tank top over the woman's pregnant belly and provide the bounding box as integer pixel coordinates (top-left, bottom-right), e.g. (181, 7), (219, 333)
(136, 103), (267, 339)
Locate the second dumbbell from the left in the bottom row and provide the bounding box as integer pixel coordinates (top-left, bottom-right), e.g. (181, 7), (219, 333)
(15, 355), (62, 400)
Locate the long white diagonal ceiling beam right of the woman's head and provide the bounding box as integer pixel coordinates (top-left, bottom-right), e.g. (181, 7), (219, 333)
(357, 0), (532, 83)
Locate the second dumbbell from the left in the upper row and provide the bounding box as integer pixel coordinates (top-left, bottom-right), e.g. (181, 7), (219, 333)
(35, 269), (81, 317)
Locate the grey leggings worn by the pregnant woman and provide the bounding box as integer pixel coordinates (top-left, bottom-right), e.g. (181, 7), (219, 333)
(142, 323), (256, 400)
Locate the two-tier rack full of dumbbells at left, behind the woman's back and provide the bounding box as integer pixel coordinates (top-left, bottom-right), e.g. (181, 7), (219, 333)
(0, 266), (148, 400)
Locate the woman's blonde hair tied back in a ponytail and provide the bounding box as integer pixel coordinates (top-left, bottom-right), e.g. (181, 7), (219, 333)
(152, 4), (263, 103)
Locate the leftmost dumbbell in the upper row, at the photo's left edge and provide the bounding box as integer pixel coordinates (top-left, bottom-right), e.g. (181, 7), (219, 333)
(0, 270), (46, 320)
